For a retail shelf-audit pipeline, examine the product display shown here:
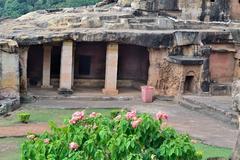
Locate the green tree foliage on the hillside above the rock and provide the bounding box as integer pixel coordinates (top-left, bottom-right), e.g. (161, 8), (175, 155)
(0, 0), (100, 18)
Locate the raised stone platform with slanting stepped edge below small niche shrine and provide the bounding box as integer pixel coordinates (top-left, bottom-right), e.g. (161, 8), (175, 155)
(179, 95), (238, 127)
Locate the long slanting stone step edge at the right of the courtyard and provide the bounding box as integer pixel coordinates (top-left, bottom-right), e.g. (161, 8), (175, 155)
(178, 98), (238, 128)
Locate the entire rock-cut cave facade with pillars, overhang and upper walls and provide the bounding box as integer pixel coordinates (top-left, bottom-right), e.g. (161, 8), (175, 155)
(0, 0), (240, 101)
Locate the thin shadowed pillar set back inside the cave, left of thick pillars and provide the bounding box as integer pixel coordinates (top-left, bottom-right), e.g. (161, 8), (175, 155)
(42, 46), (52, 88)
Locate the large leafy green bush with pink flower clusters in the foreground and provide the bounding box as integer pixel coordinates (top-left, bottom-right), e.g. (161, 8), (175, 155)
(21, 111), (201, 160)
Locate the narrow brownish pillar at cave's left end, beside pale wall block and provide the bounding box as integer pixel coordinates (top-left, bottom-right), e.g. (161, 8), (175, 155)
(18, 47), (29, 94)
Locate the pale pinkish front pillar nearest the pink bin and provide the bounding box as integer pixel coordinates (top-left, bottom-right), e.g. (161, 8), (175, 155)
(103, 43), (118, 95)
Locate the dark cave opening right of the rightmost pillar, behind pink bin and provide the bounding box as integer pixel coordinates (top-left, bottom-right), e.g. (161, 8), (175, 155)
(117, 44), (149, 92)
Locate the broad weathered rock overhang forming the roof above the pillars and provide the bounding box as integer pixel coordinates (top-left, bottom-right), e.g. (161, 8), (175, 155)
(0, 6), (240, 48)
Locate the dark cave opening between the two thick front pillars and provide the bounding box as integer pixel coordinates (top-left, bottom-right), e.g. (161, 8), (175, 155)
(73, 42), (107, 91)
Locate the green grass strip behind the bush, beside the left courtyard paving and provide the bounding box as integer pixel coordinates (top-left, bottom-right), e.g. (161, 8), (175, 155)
(0, 107), (111, 127)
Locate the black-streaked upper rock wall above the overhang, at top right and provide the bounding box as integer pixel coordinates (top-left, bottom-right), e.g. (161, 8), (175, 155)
(130, 0), (232, 21)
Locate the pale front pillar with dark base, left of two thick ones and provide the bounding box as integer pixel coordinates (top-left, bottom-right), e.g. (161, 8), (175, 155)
(59, 41), (73, 94)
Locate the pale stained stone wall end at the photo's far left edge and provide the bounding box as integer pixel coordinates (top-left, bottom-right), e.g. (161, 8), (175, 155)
(0, 41), (19, 99)
